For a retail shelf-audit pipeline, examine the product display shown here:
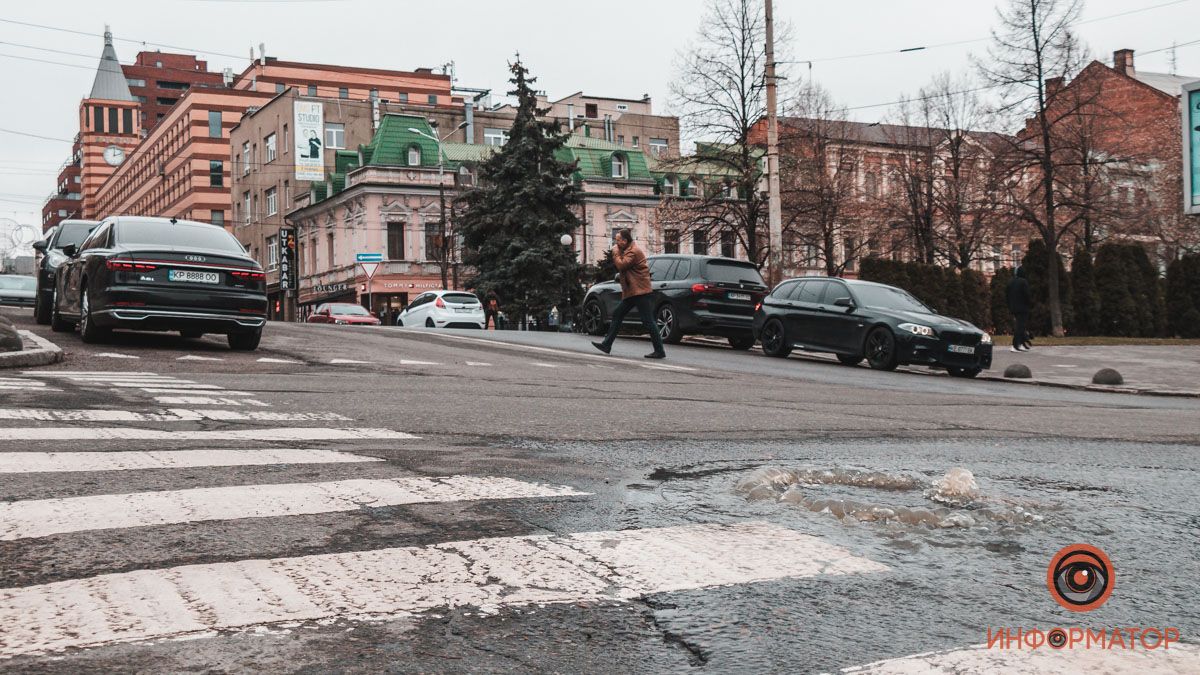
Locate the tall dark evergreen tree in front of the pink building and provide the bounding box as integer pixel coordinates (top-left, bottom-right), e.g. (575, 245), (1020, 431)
(458, 59), (581, 326)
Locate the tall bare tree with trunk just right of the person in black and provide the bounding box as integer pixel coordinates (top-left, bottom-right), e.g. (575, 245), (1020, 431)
(977, 0), (1085, 335)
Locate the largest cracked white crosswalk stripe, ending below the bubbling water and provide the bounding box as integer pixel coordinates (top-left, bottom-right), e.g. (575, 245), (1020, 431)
(0, 522), (888, 657)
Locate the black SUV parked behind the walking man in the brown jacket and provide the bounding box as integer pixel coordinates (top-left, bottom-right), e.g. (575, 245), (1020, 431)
(583, 255), (767, 350)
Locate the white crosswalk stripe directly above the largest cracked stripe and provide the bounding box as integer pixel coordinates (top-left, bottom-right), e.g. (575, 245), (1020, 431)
(0, 476), (587, 542)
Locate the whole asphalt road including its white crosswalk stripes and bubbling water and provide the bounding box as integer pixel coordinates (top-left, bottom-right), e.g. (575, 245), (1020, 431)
(0, 311), (1200, 673)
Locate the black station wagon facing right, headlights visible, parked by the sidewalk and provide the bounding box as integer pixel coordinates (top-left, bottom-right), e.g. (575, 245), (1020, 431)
(754, 277), (991, 377)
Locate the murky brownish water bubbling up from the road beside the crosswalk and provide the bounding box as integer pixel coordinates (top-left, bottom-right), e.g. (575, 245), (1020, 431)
(736, 467), (1045, 530)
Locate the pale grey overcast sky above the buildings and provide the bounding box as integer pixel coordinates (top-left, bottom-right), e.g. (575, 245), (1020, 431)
(0, 0), (1200, 241)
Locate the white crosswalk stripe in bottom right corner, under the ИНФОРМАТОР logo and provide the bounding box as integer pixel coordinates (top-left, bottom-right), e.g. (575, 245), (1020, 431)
(841, 633), (1200, 675)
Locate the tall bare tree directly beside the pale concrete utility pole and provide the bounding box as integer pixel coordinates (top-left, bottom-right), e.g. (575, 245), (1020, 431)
(660, 0), (784, 265)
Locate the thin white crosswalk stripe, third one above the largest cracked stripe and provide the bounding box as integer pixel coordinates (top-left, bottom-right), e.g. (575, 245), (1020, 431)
(2, 426), (419, 442)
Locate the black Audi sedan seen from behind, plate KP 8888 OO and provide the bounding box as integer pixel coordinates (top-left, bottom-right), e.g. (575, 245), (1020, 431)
(50, 216), (266, 350)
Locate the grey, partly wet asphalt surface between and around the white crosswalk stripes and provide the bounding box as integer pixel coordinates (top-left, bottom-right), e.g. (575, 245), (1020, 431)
(0, 306), (1200, 673)
